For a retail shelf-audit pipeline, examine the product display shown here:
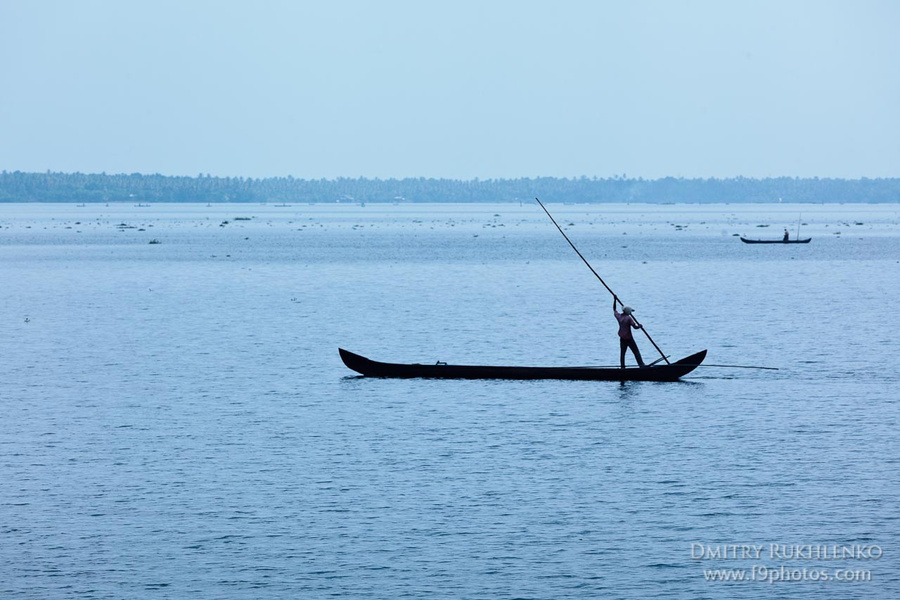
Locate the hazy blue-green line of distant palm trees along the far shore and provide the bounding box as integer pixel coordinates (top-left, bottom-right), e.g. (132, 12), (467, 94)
(0, 171), (900, 203)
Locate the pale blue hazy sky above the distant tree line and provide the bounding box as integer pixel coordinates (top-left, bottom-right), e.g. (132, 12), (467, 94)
(0, 0), (900, 179)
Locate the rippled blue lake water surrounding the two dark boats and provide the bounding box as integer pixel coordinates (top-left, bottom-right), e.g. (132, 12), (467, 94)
(0, 204), (900, 599)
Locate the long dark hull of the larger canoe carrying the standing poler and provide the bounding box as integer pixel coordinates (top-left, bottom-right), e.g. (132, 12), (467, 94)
(338, 348), (706, 381)
